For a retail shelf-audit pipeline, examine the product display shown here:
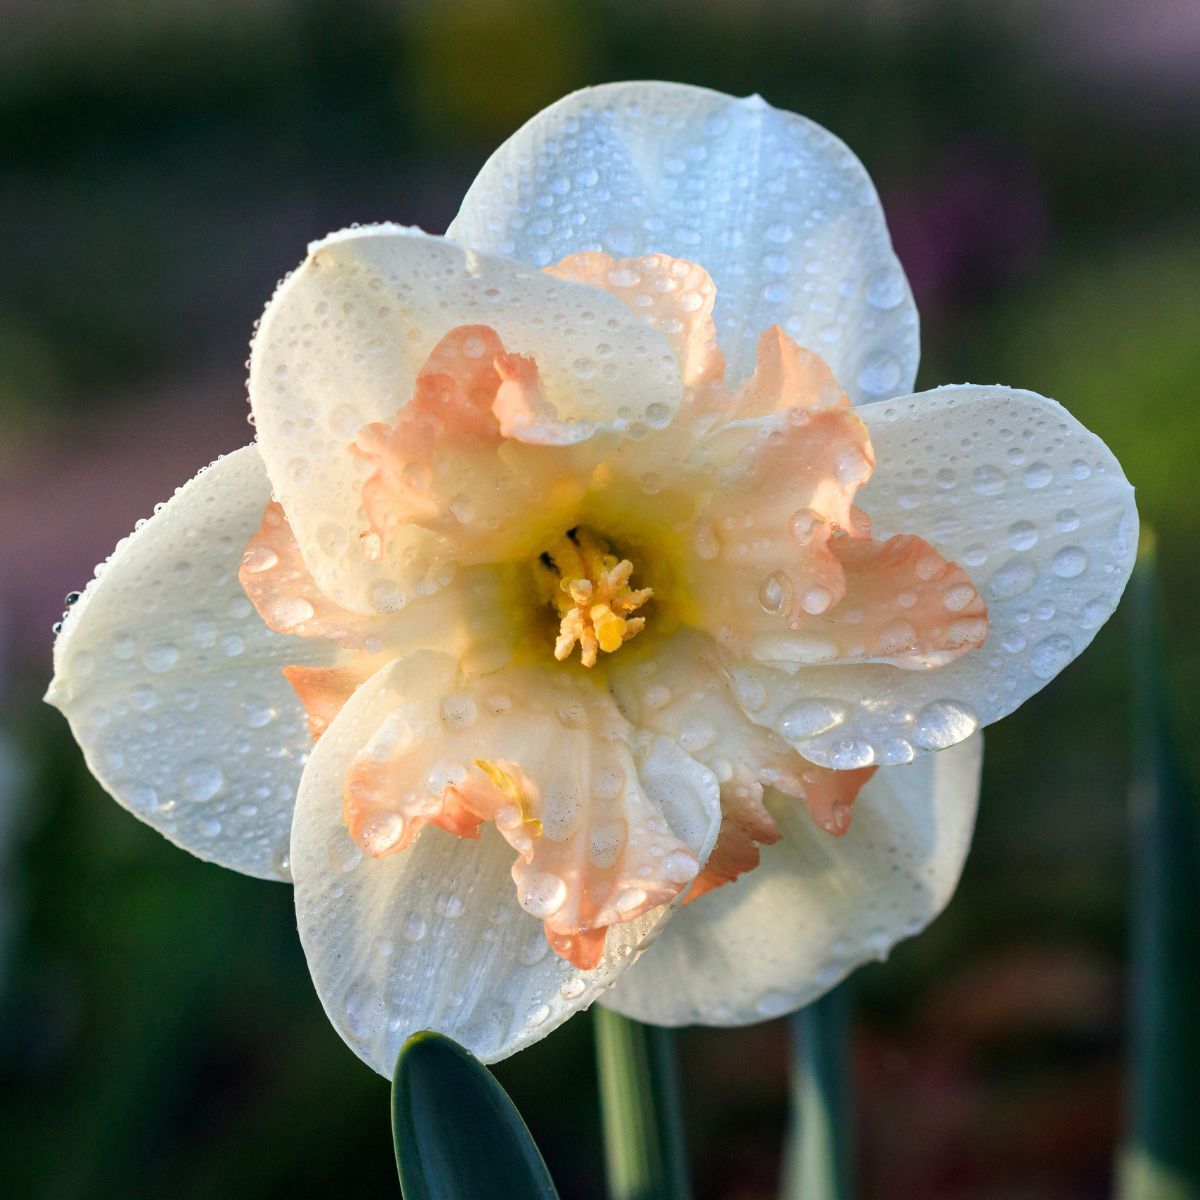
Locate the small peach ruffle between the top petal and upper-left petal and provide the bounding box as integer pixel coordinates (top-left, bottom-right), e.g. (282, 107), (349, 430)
(546, 251), (725, 403)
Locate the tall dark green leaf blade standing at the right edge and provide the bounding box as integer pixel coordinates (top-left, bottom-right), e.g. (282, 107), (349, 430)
(1118, 530), (1200, 1200)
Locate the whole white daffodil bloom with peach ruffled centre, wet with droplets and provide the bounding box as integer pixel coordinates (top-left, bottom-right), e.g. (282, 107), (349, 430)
(49, 83), (1136, 1074)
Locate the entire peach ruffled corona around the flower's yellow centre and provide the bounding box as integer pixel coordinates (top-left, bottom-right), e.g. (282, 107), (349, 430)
(234, 253), (988, 968)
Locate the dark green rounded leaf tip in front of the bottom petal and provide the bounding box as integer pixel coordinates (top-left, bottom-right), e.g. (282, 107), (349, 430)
(391, 1032), (558, 1200)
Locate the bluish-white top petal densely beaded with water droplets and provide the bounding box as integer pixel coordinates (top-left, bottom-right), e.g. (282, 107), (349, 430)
(446, 83), (919, 401)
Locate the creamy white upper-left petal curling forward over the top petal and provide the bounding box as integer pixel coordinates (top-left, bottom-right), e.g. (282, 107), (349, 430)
(250, 226), (682, 612)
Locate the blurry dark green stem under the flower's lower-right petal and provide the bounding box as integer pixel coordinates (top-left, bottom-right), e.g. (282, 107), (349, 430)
(781, 984), (852, 1200)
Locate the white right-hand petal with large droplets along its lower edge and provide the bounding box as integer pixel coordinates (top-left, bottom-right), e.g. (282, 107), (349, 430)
(739, 384), (1138, 768)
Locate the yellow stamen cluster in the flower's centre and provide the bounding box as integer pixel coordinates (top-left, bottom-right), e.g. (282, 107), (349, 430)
(540, 529), (654, 667)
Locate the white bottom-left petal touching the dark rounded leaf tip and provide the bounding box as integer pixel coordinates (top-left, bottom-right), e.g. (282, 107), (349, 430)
(292, 652), (719, 1076)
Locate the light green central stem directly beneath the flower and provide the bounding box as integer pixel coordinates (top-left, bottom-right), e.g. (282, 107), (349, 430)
(593, 1004), (691, 1200)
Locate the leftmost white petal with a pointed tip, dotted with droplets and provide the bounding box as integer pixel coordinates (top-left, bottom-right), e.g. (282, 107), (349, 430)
(46, 445), (331, 880)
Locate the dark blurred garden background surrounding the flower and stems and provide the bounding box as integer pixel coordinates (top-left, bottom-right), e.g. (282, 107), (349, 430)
(0, 0), (1200, 1200)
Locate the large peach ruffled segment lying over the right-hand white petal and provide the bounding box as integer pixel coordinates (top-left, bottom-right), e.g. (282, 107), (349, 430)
(689, 326), (988, 670)
